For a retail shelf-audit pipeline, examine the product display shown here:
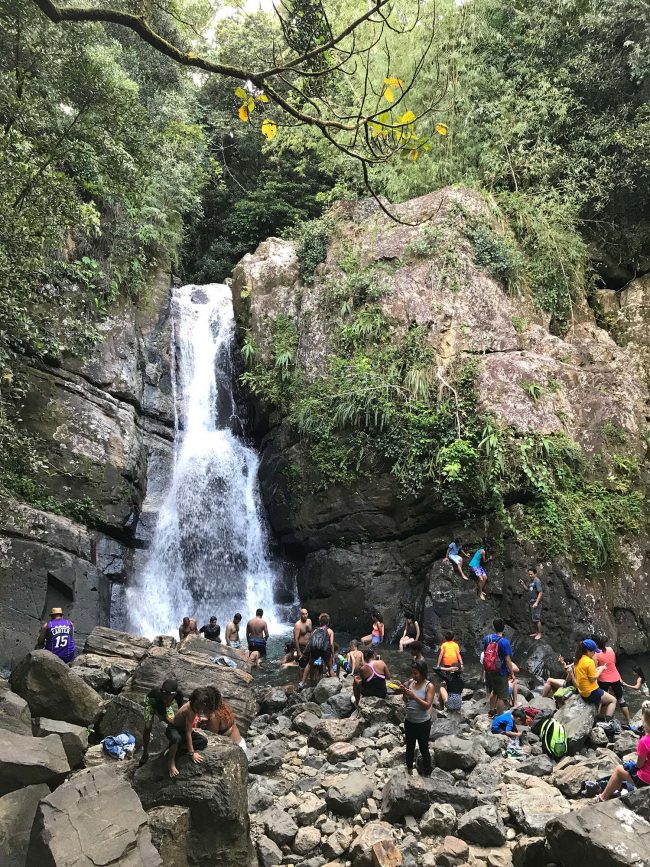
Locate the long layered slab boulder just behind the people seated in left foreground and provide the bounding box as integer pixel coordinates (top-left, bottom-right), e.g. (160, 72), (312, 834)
(121, 645), (256, 736)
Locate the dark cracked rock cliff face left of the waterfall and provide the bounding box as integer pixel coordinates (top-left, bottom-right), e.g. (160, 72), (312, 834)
(0, 275), (174, 668)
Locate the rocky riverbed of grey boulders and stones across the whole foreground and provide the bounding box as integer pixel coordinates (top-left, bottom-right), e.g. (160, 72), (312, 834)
(0, 627), (650, 867)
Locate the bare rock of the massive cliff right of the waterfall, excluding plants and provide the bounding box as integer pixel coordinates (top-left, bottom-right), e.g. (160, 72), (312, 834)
(233, 189), (650, 653)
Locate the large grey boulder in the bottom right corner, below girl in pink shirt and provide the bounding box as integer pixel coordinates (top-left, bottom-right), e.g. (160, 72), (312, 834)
(546, 800), (650, 867)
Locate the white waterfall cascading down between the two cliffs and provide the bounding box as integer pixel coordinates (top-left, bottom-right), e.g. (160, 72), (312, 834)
(126, 283), (281, 636)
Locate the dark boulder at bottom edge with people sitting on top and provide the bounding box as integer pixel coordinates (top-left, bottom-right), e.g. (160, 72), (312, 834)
(132, 735), (250, 867)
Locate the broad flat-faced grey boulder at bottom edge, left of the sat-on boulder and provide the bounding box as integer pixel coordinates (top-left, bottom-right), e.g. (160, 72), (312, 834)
(26, 767), (162, 867)
